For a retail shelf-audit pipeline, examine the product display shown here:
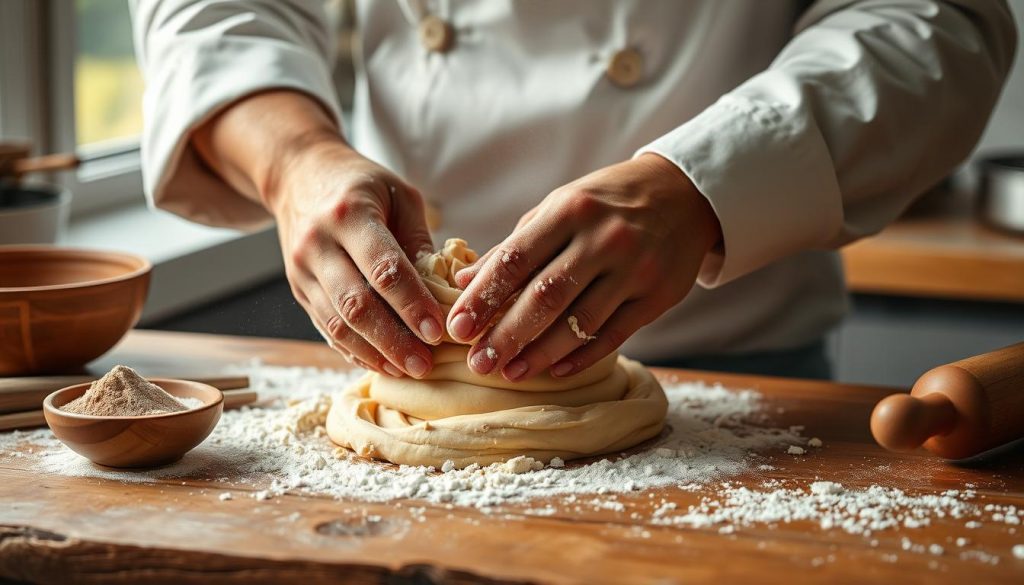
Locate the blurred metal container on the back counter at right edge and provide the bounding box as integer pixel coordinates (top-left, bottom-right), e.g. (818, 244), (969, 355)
(978, 153), (1024, 235)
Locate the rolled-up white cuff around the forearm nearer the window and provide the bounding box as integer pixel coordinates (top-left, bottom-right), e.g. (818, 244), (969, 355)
(142, 38), (341, 229)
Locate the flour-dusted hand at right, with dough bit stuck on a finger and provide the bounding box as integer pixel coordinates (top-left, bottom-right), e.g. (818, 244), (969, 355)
(447, 154), (721, 381)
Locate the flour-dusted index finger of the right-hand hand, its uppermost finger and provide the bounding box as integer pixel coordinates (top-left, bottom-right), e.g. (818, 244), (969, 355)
(447, 215), (571, 341)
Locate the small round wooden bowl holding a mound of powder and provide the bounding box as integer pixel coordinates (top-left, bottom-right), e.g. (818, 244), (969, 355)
(43, 378), (224, 467)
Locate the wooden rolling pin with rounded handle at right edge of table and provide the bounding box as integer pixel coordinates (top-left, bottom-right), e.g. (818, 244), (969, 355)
(871, 343), (1024, 459)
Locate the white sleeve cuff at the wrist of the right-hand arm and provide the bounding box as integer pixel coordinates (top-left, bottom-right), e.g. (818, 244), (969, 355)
(635, 91), (843, 288)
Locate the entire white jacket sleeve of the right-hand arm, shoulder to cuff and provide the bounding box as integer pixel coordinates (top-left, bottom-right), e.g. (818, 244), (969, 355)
(637, 0), (1017, 288)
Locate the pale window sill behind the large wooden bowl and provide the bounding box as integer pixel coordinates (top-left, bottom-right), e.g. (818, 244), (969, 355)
(61, 203), (284, 326)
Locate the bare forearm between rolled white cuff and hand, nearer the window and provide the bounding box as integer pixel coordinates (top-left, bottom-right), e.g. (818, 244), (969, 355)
(190, 90), (345, 212)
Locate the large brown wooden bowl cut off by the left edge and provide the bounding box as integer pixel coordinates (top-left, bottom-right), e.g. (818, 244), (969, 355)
(0, 246), (152, 376)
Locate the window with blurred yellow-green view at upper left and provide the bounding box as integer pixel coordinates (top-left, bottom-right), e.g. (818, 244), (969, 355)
(0, 0), (142, 215)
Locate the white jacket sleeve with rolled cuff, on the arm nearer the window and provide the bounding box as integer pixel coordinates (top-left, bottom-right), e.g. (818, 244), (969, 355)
(131, 0), (341, 228)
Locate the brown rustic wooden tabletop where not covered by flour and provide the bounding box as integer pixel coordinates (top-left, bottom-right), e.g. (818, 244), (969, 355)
(0, 331), (1024, 583)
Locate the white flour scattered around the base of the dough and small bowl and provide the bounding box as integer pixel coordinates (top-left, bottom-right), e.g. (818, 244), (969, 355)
(0, 365), (805, 508)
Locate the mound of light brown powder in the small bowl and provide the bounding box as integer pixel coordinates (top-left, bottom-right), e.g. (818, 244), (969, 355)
(60, 366), (187, 416)
